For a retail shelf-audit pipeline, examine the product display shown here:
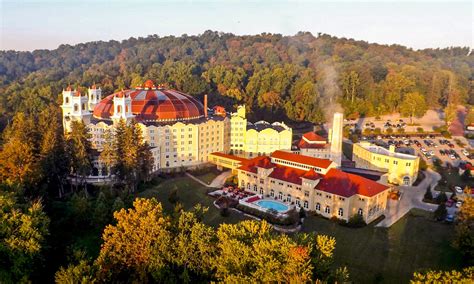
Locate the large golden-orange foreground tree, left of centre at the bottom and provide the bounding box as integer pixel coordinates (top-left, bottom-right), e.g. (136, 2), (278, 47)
(97, 198), (173, 281)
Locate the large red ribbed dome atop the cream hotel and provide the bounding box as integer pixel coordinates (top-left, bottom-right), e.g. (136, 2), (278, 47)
(93, 80), (204, 122)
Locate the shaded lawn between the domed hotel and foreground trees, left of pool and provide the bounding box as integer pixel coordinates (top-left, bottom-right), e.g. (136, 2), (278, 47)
(138, 177), (247, 227)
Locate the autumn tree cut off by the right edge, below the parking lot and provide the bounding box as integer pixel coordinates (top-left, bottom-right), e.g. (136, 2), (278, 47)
(453, 197), (474, 265)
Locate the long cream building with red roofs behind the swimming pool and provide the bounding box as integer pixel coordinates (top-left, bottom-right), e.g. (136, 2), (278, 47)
(237, 151), (390, 223)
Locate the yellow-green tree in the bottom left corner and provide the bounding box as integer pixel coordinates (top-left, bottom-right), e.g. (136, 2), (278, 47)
(0, 191), (50, 283)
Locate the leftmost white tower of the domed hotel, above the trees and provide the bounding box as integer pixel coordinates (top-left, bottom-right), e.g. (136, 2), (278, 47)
(61, 87), (91, 132)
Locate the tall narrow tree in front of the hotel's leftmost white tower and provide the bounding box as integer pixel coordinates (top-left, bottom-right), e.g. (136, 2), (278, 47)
(66, 121), (92, 196)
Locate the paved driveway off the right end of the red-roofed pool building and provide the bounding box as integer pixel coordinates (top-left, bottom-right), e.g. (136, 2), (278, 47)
(375, 169), (442, 227)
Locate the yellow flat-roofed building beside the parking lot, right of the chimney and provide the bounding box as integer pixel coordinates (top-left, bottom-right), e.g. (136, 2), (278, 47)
(352, 142), (420, 186)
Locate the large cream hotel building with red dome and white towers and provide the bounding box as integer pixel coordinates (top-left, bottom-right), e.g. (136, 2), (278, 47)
(61, 80), (292, 176)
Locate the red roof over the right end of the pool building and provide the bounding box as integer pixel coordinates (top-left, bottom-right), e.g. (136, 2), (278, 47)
(316, 169), (388, 197)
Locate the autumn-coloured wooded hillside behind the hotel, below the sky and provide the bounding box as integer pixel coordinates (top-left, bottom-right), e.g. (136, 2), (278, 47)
(0, 31), (474, 127)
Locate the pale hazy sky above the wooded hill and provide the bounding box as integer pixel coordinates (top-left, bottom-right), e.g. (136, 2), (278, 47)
(0, 0), (474, 51)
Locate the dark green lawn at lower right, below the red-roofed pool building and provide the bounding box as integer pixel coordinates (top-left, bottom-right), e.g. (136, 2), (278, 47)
(304, 209), (461, 283)
